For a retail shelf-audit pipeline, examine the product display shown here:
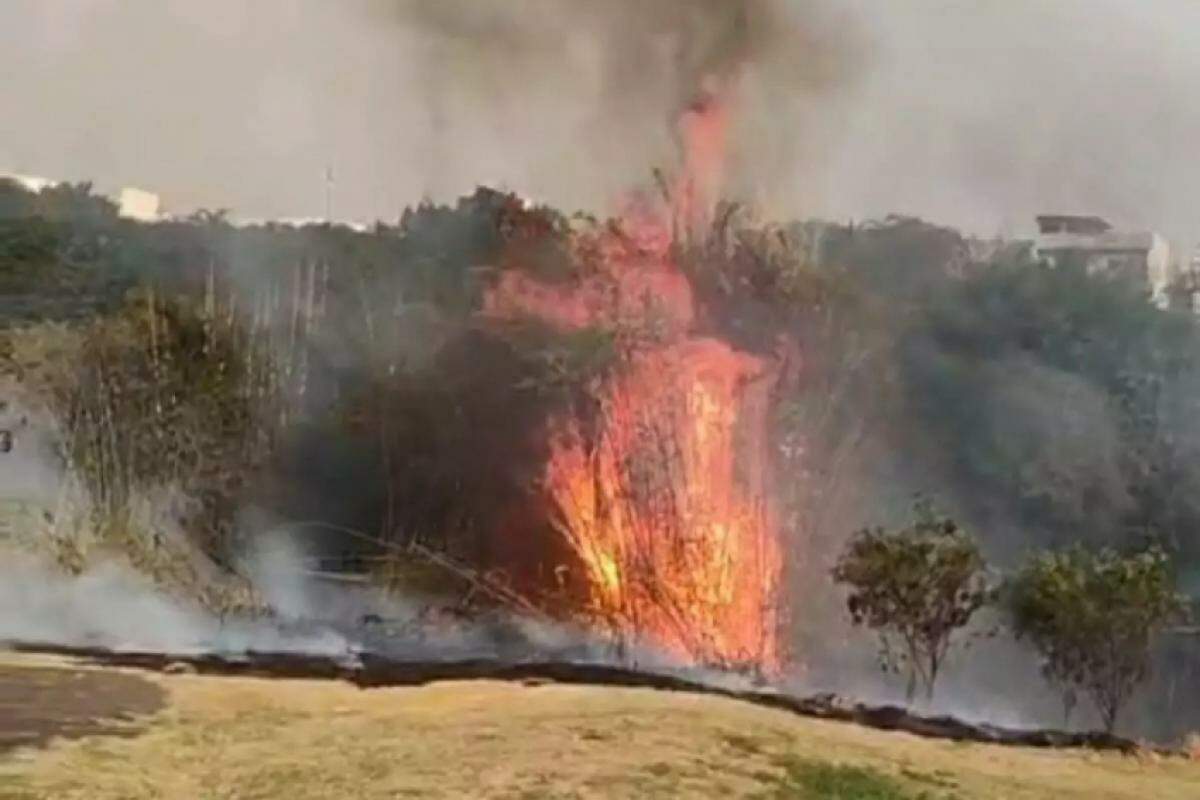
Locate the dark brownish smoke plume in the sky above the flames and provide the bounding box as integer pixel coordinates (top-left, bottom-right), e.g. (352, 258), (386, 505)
(374, 0), (862, 207)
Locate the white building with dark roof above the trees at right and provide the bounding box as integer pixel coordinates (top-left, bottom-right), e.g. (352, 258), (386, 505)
(1034, 215), (1174, 306)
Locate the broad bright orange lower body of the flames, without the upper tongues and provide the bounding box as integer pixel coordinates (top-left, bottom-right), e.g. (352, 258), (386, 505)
(545, 338), (779, 666)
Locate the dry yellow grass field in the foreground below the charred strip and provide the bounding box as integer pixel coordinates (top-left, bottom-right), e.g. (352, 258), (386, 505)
(0, 655), (1200, 800)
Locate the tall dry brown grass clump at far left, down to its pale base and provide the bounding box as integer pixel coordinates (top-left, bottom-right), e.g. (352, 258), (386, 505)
(0, 265), (323, 608)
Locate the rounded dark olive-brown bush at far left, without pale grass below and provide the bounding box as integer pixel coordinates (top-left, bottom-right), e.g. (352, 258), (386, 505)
(0, 290), (278, 553)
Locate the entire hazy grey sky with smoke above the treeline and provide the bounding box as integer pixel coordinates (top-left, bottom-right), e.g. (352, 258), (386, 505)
(0, 0), (1200, 243)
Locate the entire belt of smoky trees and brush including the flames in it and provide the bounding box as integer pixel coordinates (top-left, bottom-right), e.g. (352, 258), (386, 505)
(7, 54), (1200, 743)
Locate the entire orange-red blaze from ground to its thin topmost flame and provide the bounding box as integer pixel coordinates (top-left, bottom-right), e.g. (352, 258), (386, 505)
(485, 84), (780, 670)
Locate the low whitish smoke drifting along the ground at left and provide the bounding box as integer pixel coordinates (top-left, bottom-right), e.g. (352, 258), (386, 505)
(0, 398), (619, 668)
